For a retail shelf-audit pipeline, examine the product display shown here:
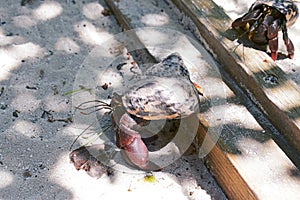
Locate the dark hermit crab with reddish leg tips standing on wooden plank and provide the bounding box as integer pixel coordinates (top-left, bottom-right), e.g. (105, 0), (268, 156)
(232, 0), (299, 60)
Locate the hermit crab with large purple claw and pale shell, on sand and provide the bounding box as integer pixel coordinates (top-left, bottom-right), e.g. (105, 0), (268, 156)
(70, 53), (202, 177)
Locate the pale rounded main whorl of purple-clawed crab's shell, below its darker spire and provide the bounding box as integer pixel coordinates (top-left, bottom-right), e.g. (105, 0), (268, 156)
(122, 76), (199, 120)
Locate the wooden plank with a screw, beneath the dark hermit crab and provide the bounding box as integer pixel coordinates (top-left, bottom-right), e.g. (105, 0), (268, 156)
(173, 0), (300, 154)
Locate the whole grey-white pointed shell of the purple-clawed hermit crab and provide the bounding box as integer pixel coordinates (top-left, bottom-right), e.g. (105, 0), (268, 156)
(118, 53), (199, 120)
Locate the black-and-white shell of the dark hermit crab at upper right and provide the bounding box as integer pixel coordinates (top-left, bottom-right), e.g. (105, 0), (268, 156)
(250, 0), (299, 26)
